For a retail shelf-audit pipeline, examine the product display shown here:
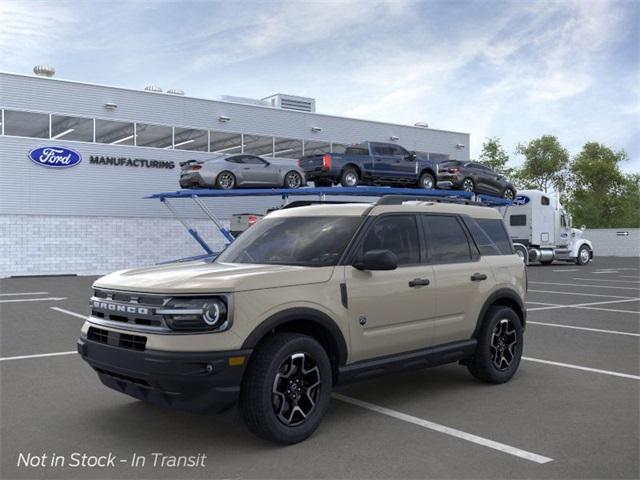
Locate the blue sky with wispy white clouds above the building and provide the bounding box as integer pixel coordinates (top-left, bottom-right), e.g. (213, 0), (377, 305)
(0, 0), (640, 172)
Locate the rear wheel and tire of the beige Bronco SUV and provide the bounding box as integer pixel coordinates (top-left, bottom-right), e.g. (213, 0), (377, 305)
(467, 305), (523, 383)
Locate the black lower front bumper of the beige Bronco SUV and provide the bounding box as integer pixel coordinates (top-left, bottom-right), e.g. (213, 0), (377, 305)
(77, 336), (251, 413)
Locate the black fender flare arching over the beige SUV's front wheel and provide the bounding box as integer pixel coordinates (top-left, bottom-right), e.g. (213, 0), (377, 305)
(242, 307), (348, 365)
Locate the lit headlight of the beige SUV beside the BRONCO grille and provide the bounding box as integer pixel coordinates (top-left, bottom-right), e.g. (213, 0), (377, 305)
(161, 297), (231, 331)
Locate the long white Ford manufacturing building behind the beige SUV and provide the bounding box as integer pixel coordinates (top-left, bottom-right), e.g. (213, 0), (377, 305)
(0, 69), (469, 277)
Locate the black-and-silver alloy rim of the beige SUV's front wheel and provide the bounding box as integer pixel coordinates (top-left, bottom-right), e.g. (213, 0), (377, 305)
(271, 353), (320, 427)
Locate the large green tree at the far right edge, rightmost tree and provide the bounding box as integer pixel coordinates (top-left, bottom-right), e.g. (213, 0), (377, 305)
(567, 142), (640, 228)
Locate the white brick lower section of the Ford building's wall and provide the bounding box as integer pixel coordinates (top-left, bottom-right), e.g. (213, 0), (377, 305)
(0, 215), (229, 277)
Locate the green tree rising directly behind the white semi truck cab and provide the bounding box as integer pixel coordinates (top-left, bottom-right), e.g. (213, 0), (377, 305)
(516, 135), (569, 192)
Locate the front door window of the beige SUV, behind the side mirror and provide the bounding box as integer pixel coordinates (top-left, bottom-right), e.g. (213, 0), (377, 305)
(361, 215), (420, 265)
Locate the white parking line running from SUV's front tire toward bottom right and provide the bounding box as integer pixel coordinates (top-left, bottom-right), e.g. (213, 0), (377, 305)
(332, 393), (553, 464)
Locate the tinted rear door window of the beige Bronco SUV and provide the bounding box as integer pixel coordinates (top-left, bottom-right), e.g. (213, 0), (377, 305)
(423, 215), (471, 263)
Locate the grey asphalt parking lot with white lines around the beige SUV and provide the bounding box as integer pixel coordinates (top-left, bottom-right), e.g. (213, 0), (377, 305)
(0, 257), (640, 478)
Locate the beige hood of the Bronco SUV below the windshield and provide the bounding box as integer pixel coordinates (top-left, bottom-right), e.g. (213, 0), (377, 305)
(94, 261), (334, 294)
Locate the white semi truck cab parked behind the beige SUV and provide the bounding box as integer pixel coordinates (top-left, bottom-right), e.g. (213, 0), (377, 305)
(502, 190), (593, 265)
